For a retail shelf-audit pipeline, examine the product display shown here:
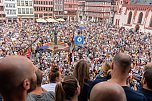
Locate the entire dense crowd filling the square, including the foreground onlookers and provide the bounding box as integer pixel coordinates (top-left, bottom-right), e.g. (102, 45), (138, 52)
(0, 20), (152, 101)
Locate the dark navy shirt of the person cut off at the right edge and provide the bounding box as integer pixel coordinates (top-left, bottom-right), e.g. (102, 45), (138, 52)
(138, 88), (152, 101)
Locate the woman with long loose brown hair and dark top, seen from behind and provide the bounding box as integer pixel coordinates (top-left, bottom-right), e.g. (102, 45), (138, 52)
(74, 60), (92, 101)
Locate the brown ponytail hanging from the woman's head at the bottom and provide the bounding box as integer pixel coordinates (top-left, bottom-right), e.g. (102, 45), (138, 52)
(55, 83), (65, 101)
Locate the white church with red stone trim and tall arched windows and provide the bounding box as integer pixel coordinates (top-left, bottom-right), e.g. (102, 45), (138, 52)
(114, 0), (152, 32)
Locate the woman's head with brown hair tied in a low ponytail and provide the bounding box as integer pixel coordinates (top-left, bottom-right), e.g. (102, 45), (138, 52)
(55, 76), (80, 101)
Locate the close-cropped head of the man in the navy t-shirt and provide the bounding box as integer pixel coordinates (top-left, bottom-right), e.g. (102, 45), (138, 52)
(111, 53), (131, 77)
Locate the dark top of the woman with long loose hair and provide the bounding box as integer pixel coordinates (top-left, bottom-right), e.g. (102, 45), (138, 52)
(78, 81), (92, 101)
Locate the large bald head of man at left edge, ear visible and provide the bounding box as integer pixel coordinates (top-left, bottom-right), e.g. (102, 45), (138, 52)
(0, 56), (36, 101)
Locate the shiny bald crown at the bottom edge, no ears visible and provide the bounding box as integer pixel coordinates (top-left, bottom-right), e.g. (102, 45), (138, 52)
(90, 82), (127, 101)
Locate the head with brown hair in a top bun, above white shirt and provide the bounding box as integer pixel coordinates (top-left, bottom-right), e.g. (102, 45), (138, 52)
(49, 64), (61, 83)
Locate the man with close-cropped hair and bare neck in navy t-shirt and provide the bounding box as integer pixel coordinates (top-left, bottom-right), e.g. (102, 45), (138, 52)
(109, 53), (146, 101)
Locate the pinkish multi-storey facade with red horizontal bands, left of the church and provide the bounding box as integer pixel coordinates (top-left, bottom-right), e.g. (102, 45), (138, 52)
(85, 0), (111, 22)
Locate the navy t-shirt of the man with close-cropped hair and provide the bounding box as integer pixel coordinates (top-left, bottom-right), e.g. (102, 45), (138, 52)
(122, 86), (147, 101)
